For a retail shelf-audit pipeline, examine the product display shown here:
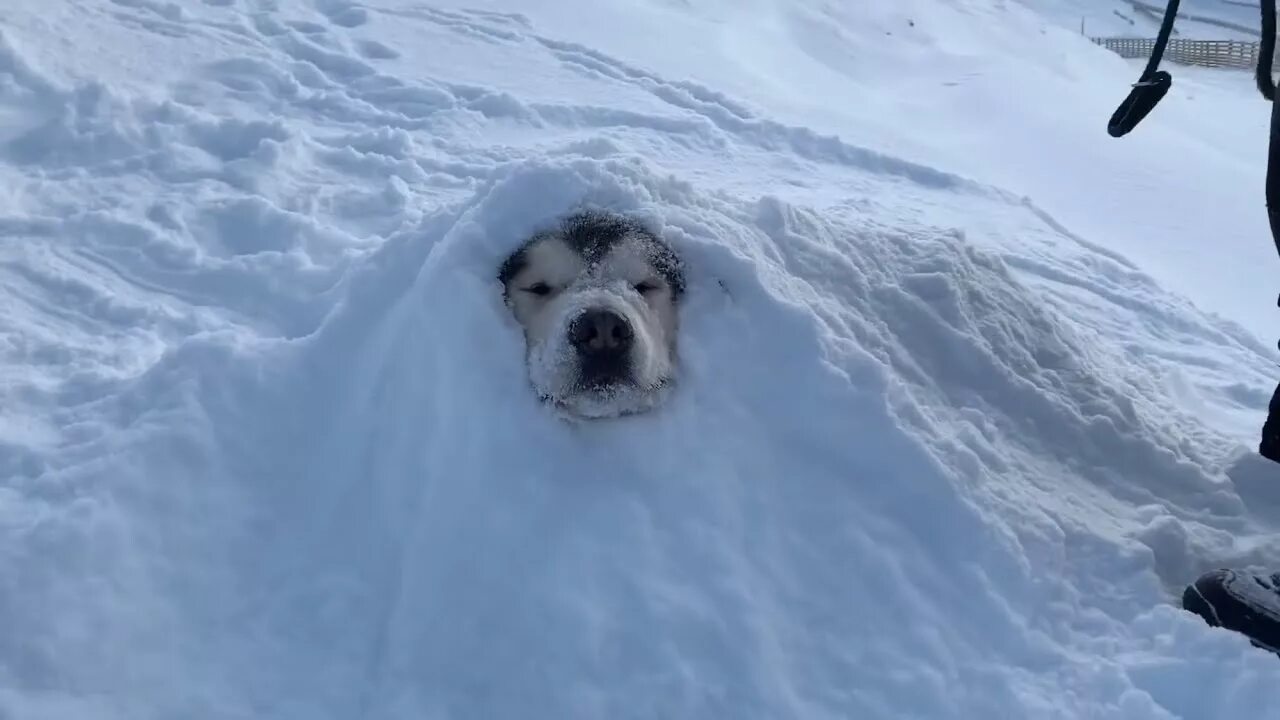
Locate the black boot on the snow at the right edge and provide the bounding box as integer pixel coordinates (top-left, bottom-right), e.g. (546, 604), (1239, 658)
(1183, 570), (1280, 655)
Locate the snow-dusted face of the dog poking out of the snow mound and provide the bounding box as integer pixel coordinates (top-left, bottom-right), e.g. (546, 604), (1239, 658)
(499, 210), (685, 419)
